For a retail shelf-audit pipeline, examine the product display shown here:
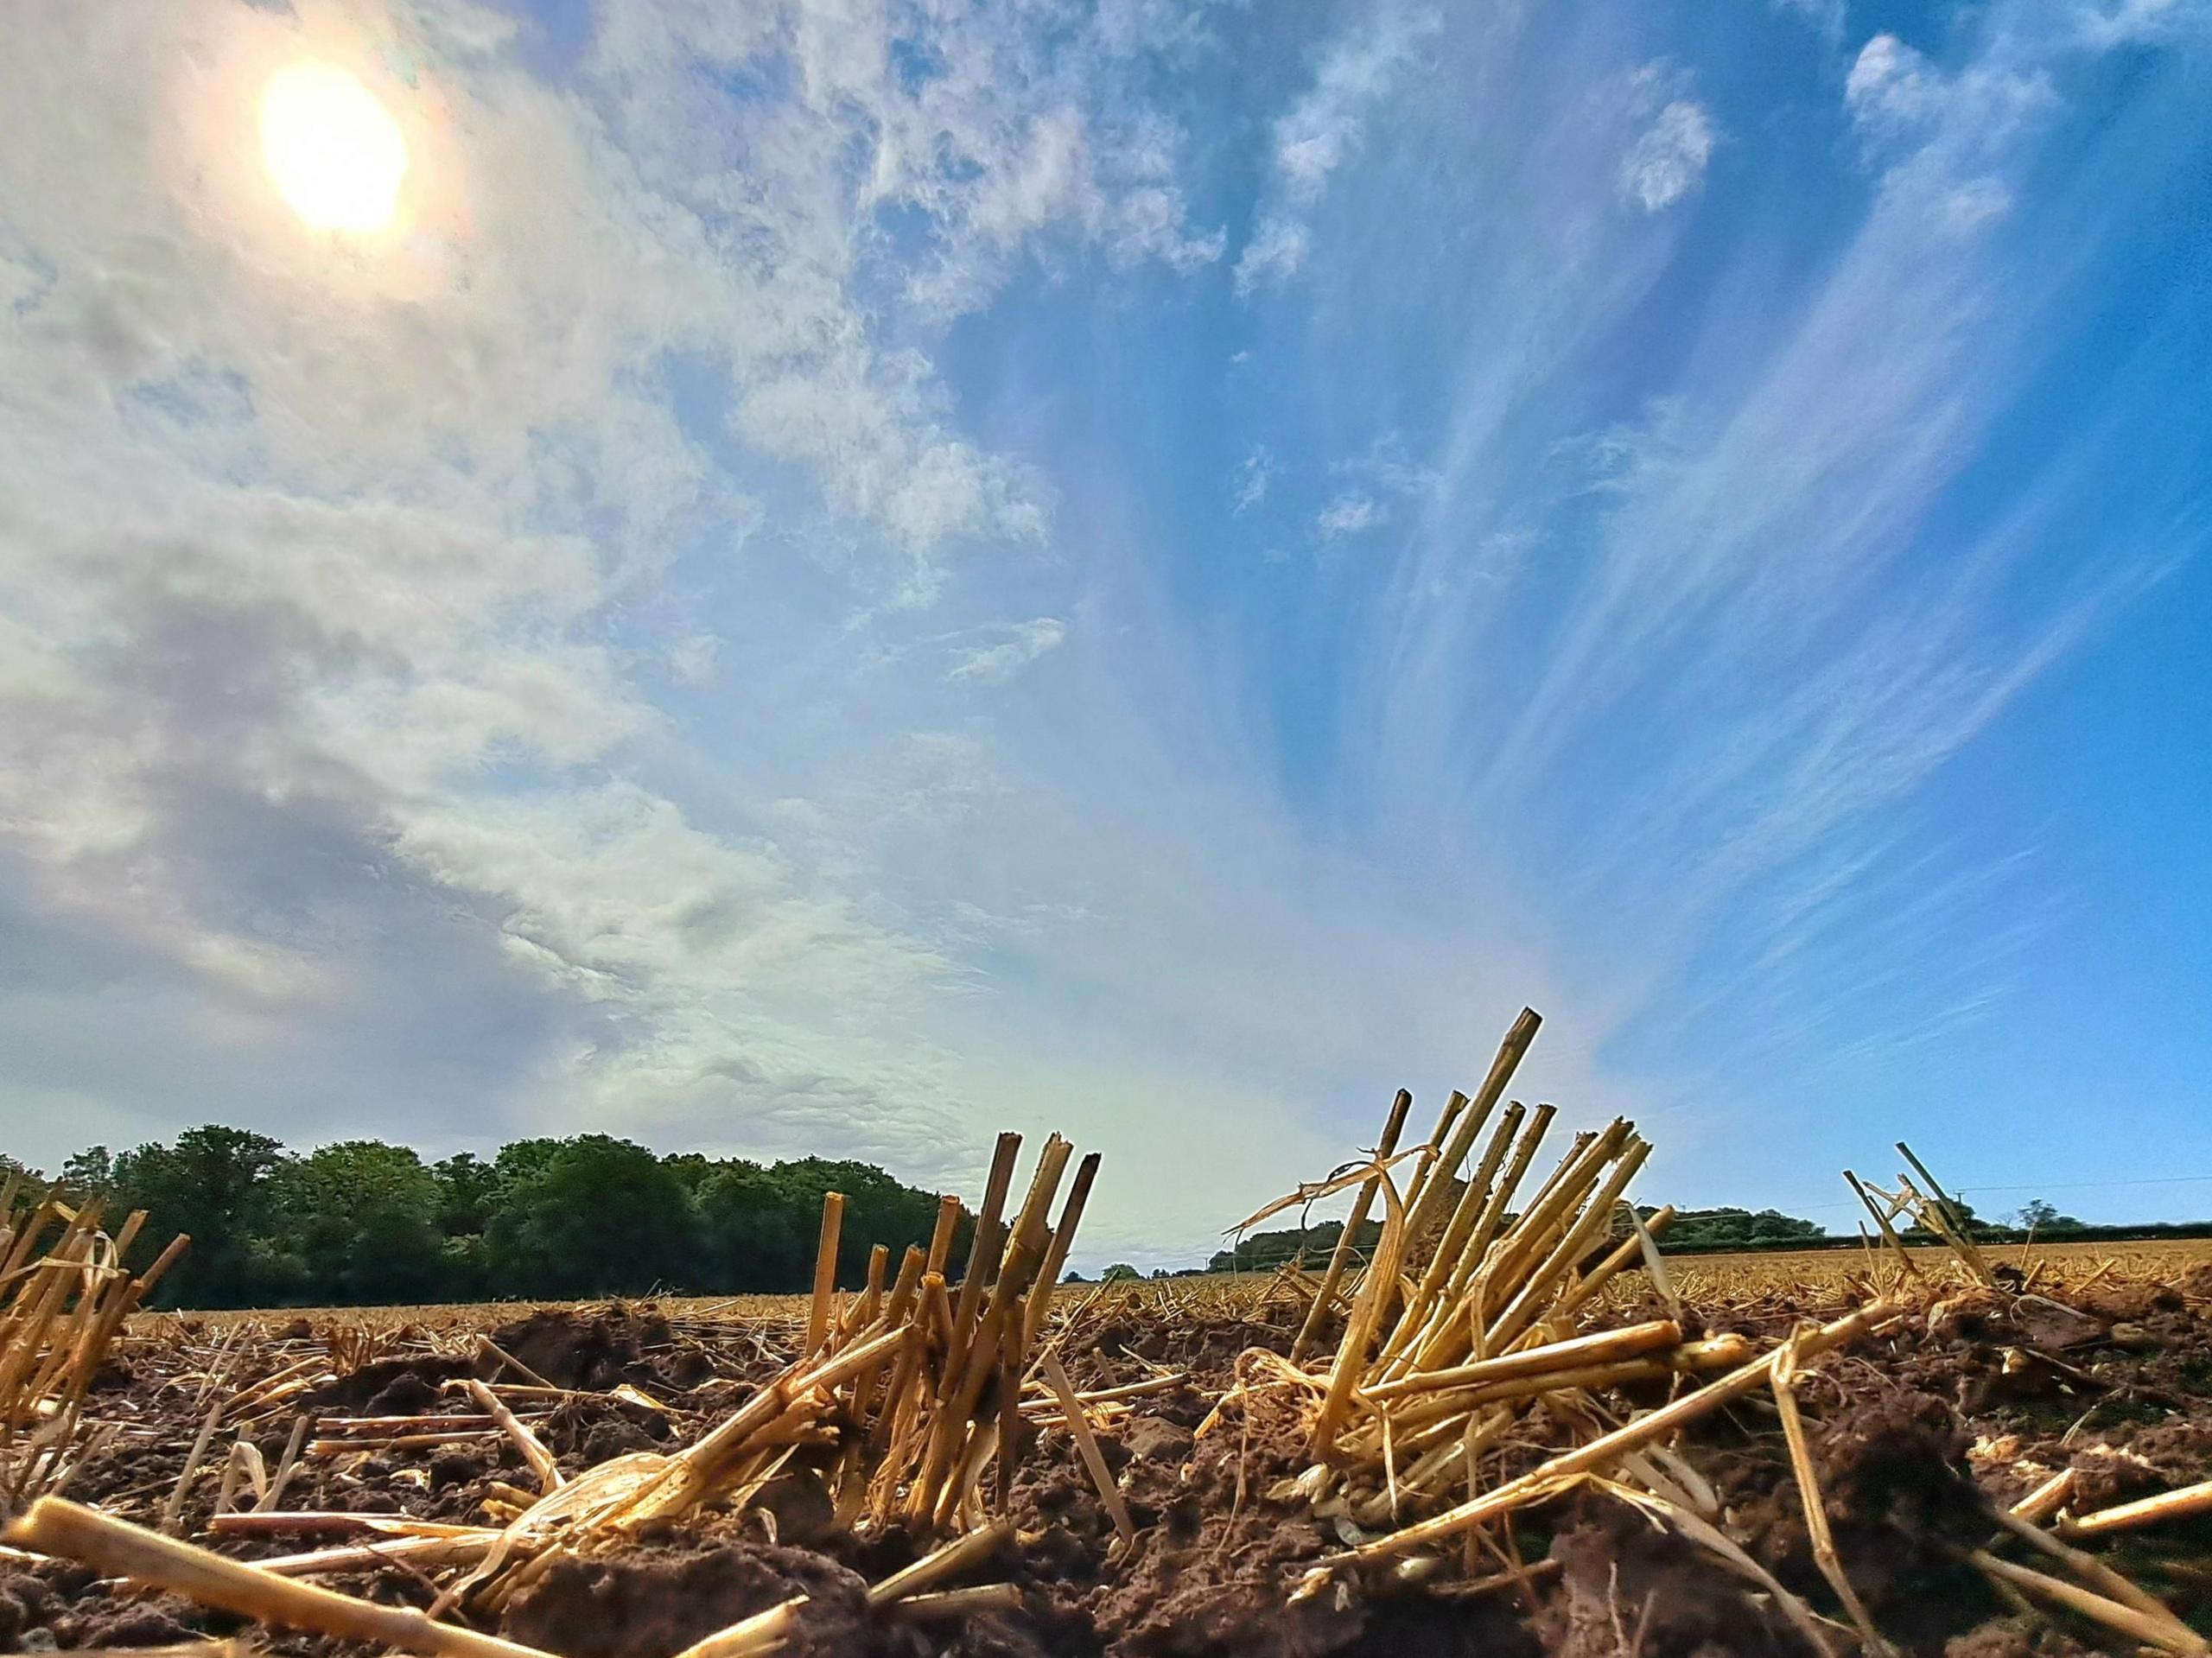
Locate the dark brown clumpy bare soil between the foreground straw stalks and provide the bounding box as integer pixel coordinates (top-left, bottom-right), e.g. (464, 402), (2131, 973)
(0, 1269), (2212, 1658)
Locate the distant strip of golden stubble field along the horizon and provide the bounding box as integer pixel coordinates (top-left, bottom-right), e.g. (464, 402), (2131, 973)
(156, 1238), (2212, 1329)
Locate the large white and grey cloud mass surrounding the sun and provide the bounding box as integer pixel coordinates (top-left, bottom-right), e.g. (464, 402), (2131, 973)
(0, 0), (1265, 1211)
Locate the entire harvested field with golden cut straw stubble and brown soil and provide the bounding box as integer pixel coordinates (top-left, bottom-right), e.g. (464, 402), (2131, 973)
(0, 1020), (2212, 1658)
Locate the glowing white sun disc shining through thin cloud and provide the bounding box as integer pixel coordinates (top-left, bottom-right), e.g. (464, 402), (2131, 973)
(261, 64), (407, 237)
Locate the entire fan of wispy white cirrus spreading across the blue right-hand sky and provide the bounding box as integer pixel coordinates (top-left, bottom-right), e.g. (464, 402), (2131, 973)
(1203, 7), (2201, 1202)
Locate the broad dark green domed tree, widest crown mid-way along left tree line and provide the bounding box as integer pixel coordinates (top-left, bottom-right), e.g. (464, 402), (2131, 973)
(485, 1134), (699, 1295)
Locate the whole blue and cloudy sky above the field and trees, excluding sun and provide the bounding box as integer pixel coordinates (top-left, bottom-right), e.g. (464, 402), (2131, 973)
(0, 0), (2212, 1265)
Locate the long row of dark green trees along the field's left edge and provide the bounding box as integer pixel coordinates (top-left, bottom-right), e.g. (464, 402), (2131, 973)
(15, 1123), (969, 1306)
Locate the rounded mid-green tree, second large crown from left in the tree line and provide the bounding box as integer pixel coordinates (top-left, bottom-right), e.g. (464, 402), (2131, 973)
(265, 1140), (445, 1302)
